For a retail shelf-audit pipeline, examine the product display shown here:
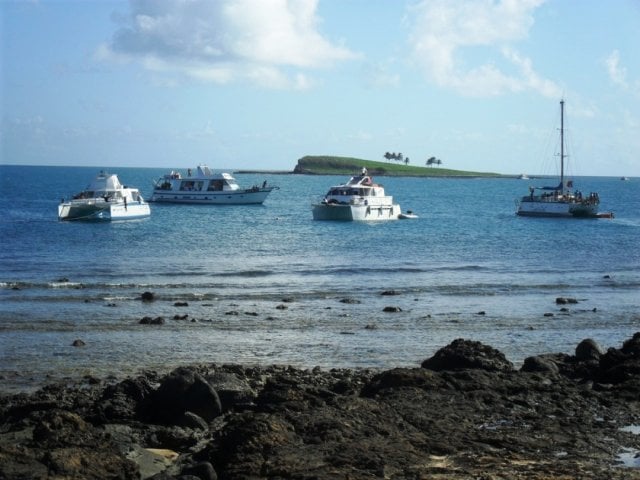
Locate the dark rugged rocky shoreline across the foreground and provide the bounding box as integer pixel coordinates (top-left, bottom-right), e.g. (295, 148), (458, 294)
(0, 333), (640, 480)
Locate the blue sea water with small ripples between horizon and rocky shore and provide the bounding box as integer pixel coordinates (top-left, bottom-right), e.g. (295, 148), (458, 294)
(0, 165), (640, 390)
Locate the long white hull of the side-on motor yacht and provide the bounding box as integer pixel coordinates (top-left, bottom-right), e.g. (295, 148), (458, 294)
(149, 187), (275, 205)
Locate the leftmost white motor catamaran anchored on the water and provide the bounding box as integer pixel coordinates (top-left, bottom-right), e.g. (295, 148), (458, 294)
(58, 172), (151, 221)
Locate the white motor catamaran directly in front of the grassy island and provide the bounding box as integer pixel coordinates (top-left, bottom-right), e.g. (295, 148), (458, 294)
(313, 168), (408, 221)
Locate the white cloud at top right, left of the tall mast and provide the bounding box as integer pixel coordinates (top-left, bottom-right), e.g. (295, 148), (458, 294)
(411, 0), (560, 97)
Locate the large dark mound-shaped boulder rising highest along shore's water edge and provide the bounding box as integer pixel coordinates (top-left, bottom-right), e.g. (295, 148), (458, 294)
(422, 338), (513, 371)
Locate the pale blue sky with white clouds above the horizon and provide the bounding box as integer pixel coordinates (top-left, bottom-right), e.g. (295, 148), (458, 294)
(0, 0), (640, 177)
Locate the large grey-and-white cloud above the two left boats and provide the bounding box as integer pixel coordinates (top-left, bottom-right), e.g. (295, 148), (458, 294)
(96, 0), (357, 89)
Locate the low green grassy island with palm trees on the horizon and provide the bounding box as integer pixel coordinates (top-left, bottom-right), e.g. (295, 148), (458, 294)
(293, 156), (504, 177)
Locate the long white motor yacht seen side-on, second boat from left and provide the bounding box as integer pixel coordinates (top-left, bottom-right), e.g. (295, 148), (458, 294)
(149, 165), (278, 205)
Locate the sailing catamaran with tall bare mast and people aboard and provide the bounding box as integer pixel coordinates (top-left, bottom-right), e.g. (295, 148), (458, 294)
(516, 100), (606, 218)
